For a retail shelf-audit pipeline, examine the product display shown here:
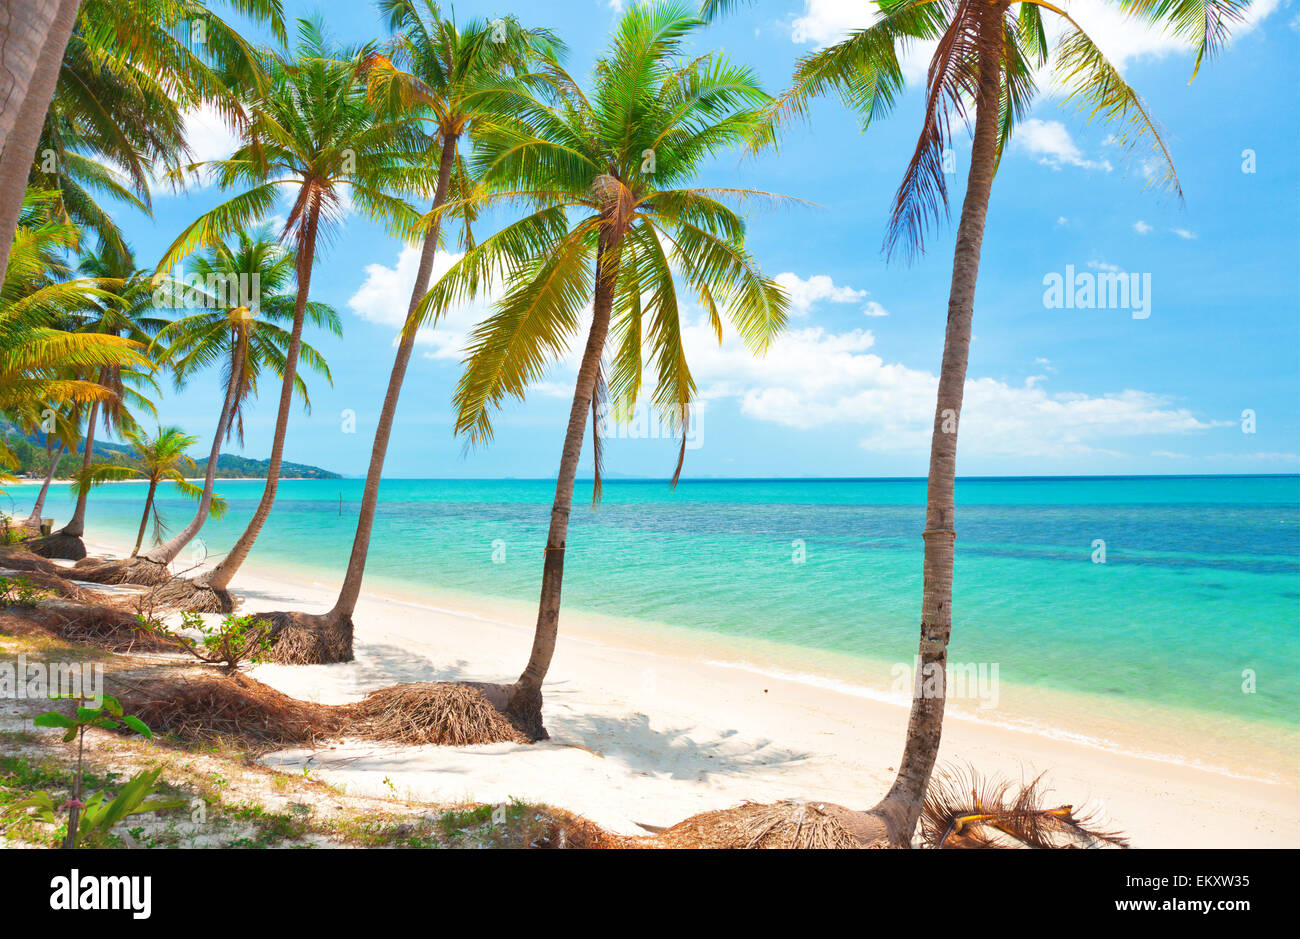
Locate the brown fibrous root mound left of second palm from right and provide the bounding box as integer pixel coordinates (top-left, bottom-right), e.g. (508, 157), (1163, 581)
(352, 681), (528, 747)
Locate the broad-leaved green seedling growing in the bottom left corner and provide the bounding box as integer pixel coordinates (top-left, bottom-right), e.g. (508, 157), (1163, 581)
(9, 694), (183, 848)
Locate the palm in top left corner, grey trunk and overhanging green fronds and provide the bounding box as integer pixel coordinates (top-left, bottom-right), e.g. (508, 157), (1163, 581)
(0, 0), (285, 278)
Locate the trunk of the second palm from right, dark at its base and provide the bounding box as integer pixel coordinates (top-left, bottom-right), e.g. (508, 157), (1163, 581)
(504, 228), (621, 740)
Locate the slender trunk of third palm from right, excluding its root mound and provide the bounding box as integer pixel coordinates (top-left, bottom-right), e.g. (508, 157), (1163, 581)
(300, 134), (456, 613)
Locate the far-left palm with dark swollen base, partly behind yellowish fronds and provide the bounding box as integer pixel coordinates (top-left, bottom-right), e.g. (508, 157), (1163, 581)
(30, 250), (166, 561)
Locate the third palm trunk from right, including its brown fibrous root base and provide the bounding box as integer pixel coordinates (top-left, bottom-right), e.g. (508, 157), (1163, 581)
(244, 134), (456, 650)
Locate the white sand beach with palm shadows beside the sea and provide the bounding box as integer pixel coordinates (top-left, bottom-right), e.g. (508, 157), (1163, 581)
(78, 538), (1300, 848)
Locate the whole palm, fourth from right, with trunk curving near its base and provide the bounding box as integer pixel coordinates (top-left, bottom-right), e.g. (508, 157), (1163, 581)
(159, 21), (426, 602)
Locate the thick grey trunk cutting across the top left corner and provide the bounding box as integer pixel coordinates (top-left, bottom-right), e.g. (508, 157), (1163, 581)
(0, 0), (81, 272)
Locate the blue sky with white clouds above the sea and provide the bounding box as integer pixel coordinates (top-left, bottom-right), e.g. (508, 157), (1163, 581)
(106, 0), (1300, 476)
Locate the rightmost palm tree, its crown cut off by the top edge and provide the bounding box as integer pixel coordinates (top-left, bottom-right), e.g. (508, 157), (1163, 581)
(705, 0), (1245, 847)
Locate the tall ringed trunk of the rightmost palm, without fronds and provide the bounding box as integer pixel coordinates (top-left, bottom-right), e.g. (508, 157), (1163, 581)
(875, 5), (1004, 847)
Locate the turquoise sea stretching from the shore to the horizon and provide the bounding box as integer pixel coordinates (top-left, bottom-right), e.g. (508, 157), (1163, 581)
(22, 476), (1300, 759)
